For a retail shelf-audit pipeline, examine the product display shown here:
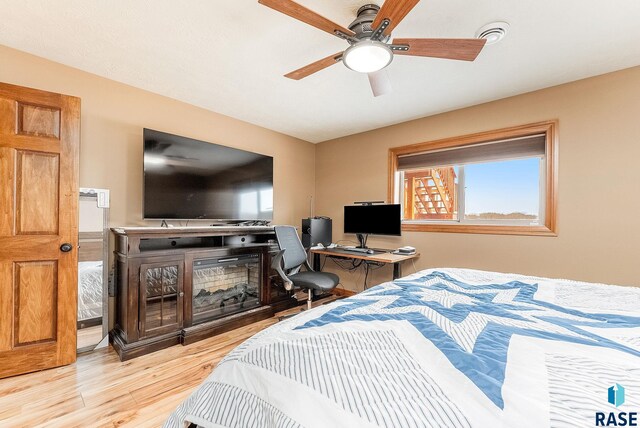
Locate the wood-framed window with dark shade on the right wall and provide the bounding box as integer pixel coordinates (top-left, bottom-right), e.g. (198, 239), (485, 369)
(389, 122), (557, 235)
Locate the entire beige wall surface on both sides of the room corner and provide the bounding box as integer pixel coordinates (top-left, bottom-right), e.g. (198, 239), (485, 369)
(0, 42), (640, 289)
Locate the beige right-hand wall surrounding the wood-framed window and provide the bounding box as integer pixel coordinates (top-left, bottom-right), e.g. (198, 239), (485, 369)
(316, 67), (640, 289)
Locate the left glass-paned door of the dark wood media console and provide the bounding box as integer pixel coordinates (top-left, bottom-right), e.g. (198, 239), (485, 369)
(139, 258), (184, 337)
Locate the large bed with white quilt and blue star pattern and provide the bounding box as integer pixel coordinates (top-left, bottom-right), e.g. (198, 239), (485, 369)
(165, 269), (640, 428)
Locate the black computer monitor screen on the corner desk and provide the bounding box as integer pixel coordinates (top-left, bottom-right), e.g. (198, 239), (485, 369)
(344, 204), (402, 236)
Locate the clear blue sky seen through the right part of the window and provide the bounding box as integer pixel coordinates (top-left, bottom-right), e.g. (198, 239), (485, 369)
(464, 158), (540, 215)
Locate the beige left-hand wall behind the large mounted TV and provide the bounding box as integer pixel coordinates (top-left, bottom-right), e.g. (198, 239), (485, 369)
(0, 46), (315, 226)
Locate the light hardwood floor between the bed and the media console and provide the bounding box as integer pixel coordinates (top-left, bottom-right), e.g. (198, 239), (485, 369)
(0, 316), (282, 428)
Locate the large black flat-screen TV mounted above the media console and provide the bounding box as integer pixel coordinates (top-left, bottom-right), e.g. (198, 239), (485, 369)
(143, 129), (273, 220)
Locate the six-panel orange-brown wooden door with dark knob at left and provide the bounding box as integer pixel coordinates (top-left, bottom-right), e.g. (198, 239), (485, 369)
(0, 83), (80, 378)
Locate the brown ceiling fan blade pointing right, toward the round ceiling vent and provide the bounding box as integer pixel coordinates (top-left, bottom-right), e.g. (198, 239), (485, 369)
(393, 39), (487, 61)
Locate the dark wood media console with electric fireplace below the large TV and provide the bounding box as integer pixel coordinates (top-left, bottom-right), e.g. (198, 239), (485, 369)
(111, 226), (292, 361)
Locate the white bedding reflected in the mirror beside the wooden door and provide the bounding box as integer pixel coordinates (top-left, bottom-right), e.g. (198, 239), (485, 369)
(78, 261), (103, 321)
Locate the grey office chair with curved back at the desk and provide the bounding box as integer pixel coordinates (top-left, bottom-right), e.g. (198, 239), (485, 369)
(271, 226), (340, 309)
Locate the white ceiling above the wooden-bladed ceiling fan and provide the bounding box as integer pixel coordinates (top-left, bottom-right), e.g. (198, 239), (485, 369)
(0, 0), (640, 142)
